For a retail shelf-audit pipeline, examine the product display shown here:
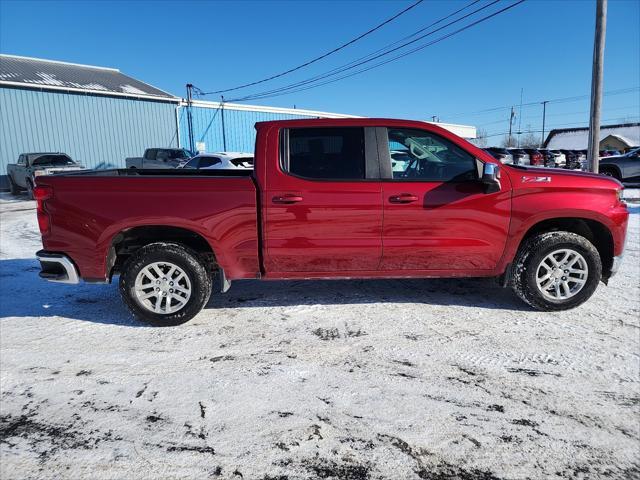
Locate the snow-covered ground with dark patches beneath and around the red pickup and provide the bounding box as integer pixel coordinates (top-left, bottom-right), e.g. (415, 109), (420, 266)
(0, 191), (640, 480)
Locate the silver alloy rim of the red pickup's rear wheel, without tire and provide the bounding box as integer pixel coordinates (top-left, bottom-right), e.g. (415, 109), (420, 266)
(134, 262), (191, 314)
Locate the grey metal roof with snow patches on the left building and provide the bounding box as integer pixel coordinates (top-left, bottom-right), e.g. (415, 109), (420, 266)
(0, 55), (176, 99)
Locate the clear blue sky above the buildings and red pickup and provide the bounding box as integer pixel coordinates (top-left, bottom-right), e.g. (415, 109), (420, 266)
(0, 0), (640, 141)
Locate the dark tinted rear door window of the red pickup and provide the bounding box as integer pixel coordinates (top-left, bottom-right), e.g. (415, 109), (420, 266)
(282, 127), (365, 180)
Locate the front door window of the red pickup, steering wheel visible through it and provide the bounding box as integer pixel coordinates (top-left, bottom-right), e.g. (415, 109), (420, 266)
(387, 128), (478, 182)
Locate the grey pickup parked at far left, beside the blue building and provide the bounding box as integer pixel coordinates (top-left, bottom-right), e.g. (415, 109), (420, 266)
(7, 152), (84, 198)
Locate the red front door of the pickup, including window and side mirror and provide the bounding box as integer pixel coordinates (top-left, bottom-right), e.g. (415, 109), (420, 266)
(378, 126), (511, 271)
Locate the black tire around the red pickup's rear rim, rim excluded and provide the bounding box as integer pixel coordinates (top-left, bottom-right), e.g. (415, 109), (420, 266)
(120, 242), (211, 326)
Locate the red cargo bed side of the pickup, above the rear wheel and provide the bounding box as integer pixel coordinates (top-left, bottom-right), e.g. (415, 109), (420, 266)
(37, 169), (260, 281)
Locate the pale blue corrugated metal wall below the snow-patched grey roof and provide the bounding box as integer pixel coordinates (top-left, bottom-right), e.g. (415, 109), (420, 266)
(0, 88), (177, 188)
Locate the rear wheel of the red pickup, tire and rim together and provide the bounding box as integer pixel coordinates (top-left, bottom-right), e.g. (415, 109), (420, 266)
(120, 242), (211, 326)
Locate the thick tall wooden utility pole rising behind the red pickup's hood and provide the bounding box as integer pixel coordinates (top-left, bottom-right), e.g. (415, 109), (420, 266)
(587, 0), (607, 173)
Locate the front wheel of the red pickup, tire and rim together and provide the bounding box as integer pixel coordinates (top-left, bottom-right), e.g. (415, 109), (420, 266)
(512, 232), (602, 311)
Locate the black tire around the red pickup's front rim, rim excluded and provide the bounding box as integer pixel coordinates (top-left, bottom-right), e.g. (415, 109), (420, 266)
(511, 231), (602, 312)
